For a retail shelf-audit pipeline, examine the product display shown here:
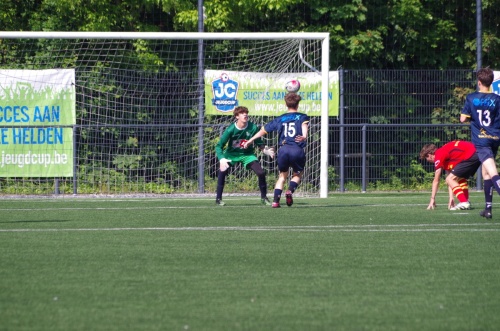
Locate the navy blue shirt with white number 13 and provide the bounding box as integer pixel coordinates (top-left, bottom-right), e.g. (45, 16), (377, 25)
(461, 92), (500, 147)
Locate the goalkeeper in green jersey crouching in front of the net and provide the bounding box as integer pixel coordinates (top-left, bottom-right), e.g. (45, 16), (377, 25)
(215, 106), (274, 206)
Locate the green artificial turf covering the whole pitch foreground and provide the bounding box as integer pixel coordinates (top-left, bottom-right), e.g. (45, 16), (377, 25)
(0, 193), (500, 331)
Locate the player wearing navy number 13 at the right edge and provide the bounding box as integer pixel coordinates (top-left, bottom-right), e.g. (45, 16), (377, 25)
(460, 68), (500, 218)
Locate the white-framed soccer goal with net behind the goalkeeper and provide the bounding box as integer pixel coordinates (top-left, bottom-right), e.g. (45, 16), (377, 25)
(0, 32), (332, 197)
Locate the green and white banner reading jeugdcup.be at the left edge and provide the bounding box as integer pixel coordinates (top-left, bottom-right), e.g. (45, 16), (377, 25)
(0, 69), (76, 177)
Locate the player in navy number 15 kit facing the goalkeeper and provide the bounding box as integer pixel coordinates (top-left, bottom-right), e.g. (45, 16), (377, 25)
(244, 93), (309, 208)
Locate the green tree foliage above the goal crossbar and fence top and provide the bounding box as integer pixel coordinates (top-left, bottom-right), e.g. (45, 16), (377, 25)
(0, 0), (500, 69)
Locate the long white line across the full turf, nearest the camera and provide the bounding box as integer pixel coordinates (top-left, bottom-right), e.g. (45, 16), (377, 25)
(0, 223), (500, 233)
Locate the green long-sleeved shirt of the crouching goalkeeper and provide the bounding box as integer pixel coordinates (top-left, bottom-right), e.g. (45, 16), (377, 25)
(215, 122), (264, 160)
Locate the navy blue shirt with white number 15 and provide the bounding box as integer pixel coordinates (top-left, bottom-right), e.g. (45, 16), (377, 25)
(264, 112), (309, 148)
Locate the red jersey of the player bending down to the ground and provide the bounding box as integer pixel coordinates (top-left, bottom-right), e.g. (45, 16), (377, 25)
(434, 140), (476, 171)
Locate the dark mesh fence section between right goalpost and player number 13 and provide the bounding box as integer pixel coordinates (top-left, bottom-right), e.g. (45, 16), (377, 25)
(329, 70), (480, 192)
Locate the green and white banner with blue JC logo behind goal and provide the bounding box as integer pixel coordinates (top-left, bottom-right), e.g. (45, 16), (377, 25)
(205, 70), (339, 116)
